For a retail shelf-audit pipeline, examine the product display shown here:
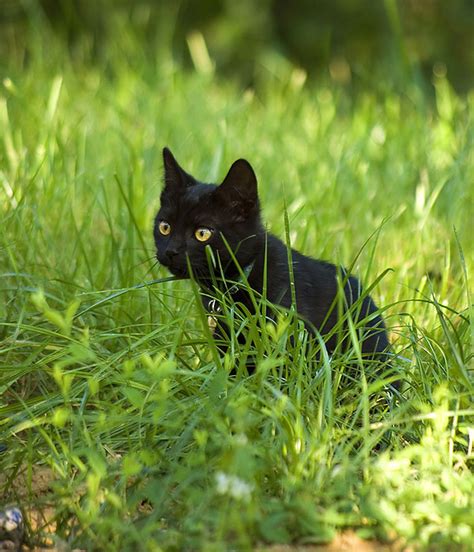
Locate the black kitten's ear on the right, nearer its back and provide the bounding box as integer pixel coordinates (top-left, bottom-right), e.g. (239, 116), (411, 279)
(217, 159), (258, 215)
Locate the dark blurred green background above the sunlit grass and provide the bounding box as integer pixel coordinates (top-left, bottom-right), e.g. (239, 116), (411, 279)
(0, 0), (474, 93)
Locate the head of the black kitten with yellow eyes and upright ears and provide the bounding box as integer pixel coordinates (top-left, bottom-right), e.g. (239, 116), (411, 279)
(154, 148), (263, 280)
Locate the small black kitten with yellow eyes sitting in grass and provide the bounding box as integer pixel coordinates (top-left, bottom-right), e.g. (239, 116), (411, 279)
(154, 148), (389, 360)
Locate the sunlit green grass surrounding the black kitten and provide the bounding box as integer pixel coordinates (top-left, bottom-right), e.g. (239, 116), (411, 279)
(0, 19), (474, 550)
